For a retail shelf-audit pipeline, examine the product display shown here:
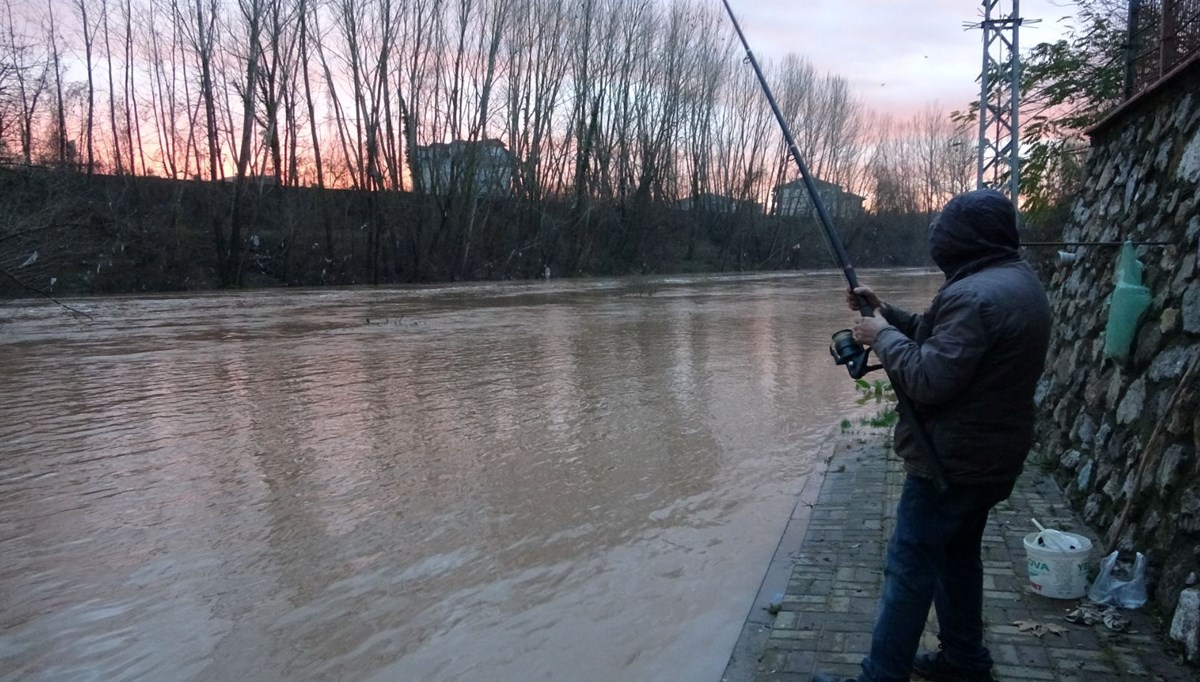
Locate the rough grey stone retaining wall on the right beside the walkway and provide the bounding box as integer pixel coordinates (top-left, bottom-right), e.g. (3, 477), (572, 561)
(1031, 59), (1200, 618)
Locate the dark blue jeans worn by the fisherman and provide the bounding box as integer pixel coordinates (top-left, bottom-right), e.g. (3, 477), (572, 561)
(859, 475), (1013, 682)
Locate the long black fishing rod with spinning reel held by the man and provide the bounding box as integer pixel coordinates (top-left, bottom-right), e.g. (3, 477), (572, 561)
(721, 0), (948, 492)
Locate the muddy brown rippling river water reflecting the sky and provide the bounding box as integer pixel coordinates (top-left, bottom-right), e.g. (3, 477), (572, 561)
(0, 270), (940, 682)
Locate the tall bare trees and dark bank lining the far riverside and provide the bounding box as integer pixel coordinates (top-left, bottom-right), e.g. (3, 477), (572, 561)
(0, 0), (973, 291)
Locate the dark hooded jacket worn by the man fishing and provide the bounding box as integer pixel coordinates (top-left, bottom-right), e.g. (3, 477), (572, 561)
(874, 190), (1050, 484)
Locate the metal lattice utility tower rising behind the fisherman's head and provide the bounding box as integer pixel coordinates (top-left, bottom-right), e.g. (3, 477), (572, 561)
(966, 0), (1025, 204)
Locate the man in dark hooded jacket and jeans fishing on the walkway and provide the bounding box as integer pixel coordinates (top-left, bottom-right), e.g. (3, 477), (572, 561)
(812, 190), (1050, 682)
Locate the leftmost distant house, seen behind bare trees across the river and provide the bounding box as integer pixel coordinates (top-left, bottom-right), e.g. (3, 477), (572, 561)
(415, 139), (516, 197)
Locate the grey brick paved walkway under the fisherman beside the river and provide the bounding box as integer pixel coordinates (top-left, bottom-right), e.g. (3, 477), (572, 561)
(724, 433), (1200, 682)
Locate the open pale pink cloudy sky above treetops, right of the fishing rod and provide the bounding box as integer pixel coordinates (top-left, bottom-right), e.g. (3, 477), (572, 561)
(730, 0), (1075, 115)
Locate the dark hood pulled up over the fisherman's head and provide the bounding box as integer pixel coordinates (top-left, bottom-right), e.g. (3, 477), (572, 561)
(929, 190), (1021, 282)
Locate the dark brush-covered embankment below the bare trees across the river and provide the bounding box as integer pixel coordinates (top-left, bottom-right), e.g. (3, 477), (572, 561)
(0, 168), (928, 297)
